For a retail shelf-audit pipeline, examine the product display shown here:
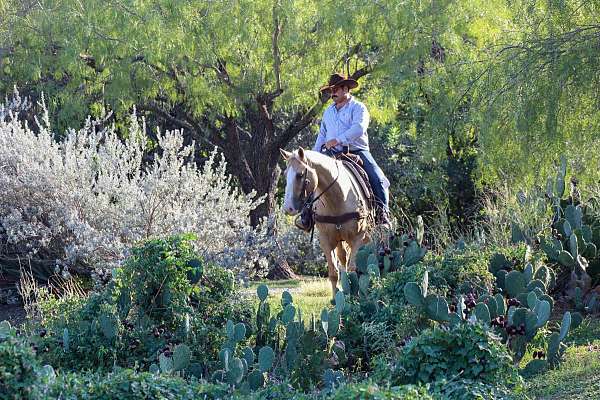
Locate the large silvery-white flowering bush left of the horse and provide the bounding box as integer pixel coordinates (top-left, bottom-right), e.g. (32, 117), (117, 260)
(0, 89), (272, 280)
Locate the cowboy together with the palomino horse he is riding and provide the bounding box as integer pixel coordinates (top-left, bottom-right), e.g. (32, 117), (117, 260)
(281, 74), (389, 296)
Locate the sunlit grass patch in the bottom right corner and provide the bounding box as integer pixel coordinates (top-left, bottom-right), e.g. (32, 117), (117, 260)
(526, 318), (600, 400)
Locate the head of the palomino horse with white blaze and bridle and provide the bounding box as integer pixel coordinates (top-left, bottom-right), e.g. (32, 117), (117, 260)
(280, 147), (319, 215)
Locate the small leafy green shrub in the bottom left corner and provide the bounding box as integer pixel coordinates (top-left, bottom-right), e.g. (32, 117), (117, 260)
(0, 321), (39, 400)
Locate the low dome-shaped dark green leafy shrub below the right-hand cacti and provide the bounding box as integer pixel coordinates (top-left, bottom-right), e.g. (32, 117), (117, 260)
(376, 323), (519, 385)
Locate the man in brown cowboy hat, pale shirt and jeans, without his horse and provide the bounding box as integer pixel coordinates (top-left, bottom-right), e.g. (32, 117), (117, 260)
(313, 74), (390, 226)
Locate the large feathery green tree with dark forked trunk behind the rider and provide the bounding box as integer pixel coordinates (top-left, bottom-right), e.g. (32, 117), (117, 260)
(0, 0), (418, 225)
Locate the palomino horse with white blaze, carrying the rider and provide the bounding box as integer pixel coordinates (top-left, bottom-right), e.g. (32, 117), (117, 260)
(281, 147), (371, 296)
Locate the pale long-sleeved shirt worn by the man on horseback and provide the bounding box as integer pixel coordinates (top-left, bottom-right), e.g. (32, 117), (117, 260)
(313, 97), (369, 151)
